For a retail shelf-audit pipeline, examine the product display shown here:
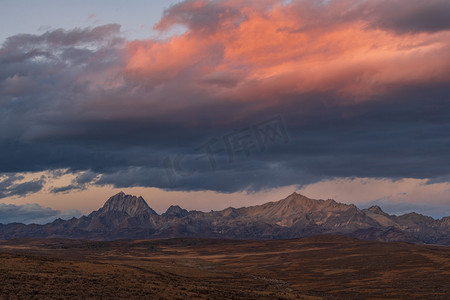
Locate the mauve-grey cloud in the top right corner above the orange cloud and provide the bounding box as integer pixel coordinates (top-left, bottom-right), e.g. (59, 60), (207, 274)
(279, 0), (450, 34)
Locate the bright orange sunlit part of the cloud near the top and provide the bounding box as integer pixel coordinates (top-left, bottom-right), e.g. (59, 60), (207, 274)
(125, 0), (450, 101)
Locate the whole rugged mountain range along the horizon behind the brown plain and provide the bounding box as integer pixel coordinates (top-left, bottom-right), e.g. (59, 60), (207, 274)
(0, 192), (450, 245)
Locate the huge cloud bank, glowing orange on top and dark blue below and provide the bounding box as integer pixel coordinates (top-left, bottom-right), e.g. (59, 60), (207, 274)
(0, 1), (450, 197)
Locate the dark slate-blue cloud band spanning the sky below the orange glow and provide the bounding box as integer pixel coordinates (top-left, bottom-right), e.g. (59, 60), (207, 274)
(0, 85), (450, 192)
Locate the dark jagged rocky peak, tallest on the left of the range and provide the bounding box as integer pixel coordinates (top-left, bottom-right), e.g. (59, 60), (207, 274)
(99, 192), (156, 216)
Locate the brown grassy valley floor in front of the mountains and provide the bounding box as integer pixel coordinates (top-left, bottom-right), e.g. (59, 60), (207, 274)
(0, 235), (450, 299)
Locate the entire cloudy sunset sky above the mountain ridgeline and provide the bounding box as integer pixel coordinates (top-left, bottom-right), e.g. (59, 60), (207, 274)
(0, 0), (450, 223)
